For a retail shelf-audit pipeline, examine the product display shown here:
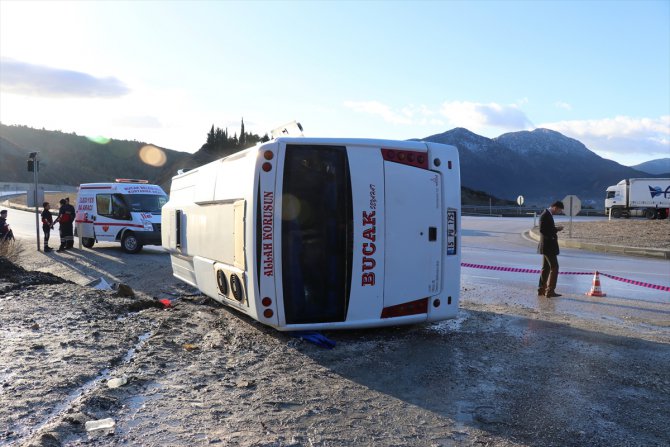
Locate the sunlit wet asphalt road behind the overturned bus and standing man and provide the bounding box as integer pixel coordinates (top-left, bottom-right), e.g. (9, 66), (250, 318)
(8, 209), (670, 332)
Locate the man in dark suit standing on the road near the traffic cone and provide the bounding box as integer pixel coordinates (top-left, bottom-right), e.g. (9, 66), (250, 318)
(537, 200), (564, 298)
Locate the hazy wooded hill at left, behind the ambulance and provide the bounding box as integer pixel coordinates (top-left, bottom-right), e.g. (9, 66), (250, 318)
(0, 124), (191, 189)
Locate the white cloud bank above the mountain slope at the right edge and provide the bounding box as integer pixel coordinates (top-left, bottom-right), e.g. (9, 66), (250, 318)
(538, 115), (670, 160)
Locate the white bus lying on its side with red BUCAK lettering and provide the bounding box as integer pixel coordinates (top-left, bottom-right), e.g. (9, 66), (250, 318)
(162, 137), (461, 331)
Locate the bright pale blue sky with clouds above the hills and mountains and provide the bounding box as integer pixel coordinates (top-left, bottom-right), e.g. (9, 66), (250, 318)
(0, 0), (670, 166)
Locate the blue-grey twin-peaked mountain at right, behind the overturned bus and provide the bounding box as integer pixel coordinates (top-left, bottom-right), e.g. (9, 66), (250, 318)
(423, 128), (648, 206)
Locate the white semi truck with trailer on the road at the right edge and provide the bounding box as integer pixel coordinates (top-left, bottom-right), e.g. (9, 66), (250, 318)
(605, 178), (670, 219)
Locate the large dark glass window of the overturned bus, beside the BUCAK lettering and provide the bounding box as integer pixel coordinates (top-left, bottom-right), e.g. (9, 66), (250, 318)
(281, 144), (353, 324)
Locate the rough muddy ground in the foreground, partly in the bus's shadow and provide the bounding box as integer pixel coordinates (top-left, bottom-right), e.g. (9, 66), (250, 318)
(0, 223), (670, 447)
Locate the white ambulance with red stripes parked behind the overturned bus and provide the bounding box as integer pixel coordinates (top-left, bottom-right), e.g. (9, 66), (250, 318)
(75, 179), (168, 253)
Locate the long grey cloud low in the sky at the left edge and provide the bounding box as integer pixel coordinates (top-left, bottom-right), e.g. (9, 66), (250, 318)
(0, 58), (130, 98)
